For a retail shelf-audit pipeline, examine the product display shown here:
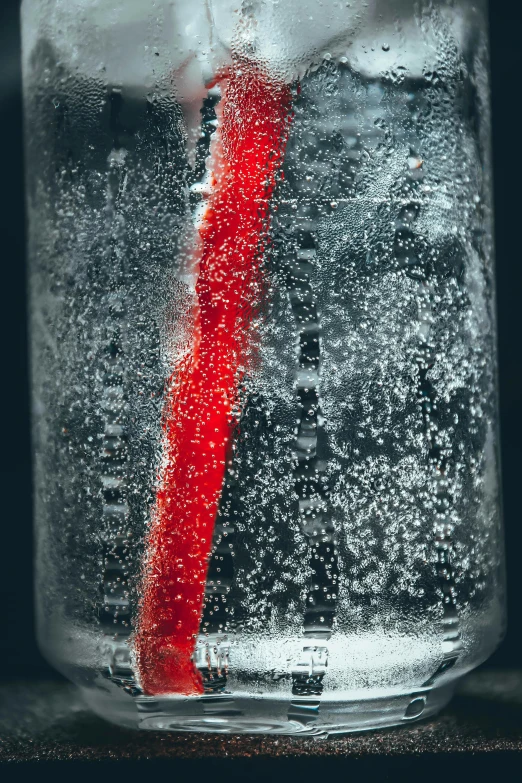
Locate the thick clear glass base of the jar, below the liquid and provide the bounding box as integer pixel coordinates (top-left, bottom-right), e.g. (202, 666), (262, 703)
(82, 681), (456, 738)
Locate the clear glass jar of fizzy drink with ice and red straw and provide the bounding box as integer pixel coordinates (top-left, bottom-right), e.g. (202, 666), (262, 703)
(22, 0), (504, 735)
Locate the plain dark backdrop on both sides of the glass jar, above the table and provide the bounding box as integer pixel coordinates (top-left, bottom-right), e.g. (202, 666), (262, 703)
(0, 0), (522, 679)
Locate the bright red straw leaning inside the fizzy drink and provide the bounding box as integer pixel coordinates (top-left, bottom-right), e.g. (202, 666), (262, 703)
(135, 62), (291, 695)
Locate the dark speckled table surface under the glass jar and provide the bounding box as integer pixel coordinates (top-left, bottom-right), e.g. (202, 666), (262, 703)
(0, 669), (522, 780)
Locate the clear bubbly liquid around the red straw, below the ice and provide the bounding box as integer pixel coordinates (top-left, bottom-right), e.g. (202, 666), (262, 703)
(25, 15), (502, 732)
